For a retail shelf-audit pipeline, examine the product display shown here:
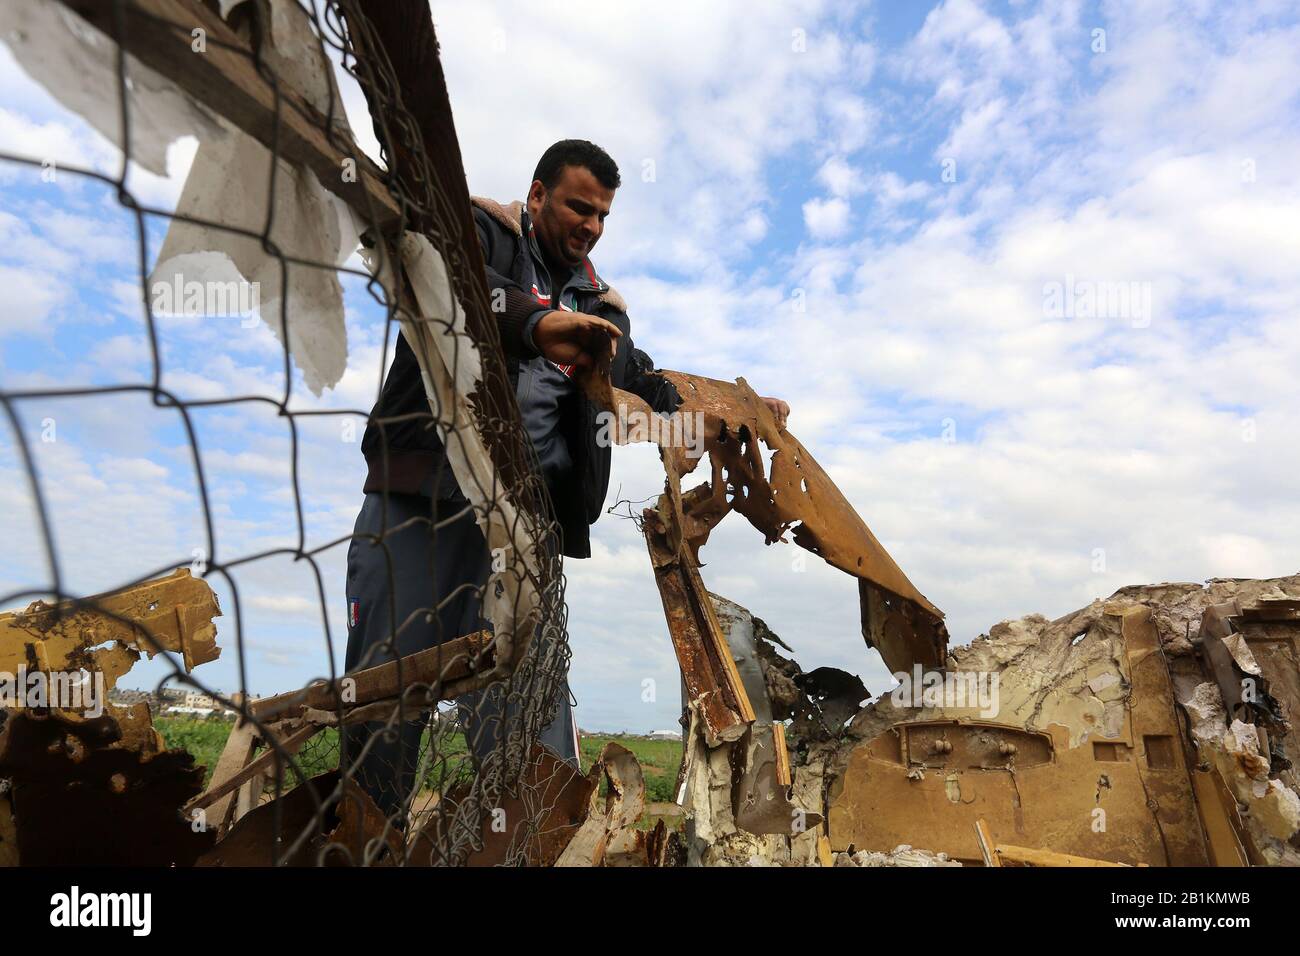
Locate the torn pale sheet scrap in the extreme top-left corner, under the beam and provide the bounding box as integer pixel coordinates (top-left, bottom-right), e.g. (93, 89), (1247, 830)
(0, 0), (229, 176)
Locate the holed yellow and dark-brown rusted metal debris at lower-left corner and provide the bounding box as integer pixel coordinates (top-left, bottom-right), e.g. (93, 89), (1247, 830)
(0, 568), (221, 866)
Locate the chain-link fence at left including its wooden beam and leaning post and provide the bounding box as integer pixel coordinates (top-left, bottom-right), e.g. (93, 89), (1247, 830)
(0, 0), (569, 865)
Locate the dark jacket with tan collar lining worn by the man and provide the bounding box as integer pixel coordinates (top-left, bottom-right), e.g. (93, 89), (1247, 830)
(361, 198), (680, 558)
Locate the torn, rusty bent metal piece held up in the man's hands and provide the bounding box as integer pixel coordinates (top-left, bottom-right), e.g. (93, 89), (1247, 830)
(584, 362), (948, 862)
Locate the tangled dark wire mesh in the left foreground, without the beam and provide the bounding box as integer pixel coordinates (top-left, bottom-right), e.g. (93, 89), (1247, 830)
(0, 0), (569, 865)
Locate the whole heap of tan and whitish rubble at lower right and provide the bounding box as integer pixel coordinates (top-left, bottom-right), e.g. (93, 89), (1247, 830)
(707, 575), (1300, 866)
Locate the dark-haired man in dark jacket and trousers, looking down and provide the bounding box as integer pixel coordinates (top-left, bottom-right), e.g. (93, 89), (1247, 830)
(346, 139), (789, 814)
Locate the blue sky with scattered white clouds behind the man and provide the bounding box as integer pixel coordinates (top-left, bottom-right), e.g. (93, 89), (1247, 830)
(0, 0), (1300, 731)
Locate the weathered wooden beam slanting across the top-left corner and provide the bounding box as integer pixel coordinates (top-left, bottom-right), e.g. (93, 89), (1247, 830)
(60, 0), (402, 228)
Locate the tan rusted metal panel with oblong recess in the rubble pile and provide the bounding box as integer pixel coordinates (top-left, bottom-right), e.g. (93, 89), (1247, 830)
(829, 604), (1209, 866)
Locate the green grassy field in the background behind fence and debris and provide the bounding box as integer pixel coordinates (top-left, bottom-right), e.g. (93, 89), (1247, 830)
(153, 717), (681, 803)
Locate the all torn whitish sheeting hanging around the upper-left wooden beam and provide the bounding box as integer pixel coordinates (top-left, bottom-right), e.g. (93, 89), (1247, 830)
(3, 0), (359, 395)
